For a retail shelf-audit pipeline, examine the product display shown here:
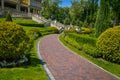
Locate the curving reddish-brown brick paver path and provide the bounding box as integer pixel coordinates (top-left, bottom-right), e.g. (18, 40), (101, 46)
(40, 34), (119, 80)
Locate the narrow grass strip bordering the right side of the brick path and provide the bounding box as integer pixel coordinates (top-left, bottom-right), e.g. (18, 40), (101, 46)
(59, 34), (120, 79)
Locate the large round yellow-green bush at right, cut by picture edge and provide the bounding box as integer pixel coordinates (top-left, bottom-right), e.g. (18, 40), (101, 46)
(96, 26), (120, 63)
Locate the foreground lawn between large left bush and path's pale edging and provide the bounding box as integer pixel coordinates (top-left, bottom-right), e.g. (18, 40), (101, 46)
(0, 38), (48, 80)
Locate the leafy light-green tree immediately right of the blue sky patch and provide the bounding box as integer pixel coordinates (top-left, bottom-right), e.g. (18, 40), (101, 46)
(69, 0), (86, 25)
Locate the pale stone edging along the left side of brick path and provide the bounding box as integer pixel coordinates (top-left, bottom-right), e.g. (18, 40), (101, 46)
(37, 37), (55, 80)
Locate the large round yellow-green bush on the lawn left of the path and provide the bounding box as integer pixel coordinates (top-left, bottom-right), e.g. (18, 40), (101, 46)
(0, 22), (32, 62)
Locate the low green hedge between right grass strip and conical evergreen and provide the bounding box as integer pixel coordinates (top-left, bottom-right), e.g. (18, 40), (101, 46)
(64, 33), (101, 57)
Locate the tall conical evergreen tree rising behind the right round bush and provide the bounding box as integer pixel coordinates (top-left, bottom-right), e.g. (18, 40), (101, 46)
(95, 0), (111, 37)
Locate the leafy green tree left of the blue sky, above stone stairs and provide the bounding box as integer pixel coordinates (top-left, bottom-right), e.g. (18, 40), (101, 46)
(41, 0), (61, 19)
